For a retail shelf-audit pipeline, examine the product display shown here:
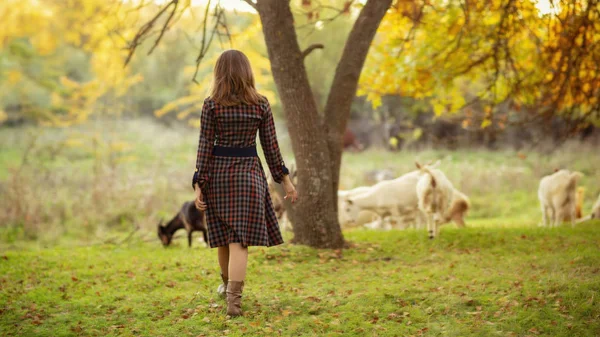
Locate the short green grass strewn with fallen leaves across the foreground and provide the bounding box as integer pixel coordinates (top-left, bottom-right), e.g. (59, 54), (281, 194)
(0, 223), (600, 336)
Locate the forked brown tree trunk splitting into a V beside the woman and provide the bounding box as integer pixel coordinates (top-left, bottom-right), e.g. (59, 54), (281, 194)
(256, 0), (392, 248)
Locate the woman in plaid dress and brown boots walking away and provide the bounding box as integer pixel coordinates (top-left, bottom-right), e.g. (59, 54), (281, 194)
(192, 50), (298, 316)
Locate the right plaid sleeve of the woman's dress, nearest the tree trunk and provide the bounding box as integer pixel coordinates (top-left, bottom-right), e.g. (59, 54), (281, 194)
(258, 102), (289, 183)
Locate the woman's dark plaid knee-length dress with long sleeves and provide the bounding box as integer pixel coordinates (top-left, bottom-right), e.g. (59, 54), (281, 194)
(192, 98), (287, 248)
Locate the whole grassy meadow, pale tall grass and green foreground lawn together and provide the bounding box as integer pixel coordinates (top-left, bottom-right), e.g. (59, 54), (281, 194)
(0, 120), (600, 336)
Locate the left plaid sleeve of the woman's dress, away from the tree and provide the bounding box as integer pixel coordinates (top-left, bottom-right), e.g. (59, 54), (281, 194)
(192, 100), (215, 190)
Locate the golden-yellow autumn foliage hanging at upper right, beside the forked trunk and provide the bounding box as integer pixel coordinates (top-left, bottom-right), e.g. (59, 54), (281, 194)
(359, 0), (600, 135)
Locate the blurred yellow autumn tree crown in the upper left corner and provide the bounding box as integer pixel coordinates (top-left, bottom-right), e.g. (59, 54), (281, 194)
(0, 0), (143, 127)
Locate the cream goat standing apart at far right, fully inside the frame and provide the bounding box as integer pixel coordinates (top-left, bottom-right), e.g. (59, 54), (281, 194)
(538, 170), (583, 226)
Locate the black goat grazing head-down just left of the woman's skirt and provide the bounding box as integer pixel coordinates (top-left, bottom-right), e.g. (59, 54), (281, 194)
(158, 201), (208, 247)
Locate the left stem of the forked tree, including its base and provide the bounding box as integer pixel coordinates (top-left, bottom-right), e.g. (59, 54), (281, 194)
(256, 0), (344, 248)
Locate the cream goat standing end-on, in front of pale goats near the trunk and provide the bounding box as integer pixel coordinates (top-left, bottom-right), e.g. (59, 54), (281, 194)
(416, 163), (455, 239)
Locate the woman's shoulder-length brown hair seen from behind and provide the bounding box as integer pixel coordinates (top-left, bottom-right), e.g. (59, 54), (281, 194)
(210, 49), (264, 106)
